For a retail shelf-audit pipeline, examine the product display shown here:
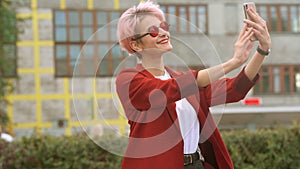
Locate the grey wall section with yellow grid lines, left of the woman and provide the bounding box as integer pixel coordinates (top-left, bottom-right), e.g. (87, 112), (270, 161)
(7, 0), (126, 137)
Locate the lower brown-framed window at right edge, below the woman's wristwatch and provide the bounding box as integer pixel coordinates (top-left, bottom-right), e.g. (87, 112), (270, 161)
(254, 65), (300, 94)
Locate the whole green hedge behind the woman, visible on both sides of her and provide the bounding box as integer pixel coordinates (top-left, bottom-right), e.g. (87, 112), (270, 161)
(0, 125), (300, 169)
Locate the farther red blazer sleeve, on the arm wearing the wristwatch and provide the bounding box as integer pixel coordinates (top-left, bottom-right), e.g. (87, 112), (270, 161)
(204, 68), (259, 106)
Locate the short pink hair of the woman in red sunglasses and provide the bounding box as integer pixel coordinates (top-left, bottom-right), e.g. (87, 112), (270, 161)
(117, 0), (165, 54)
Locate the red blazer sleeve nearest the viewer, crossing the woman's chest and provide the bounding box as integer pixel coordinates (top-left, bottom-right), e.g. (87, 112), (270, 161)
(116, 69), (199, 110)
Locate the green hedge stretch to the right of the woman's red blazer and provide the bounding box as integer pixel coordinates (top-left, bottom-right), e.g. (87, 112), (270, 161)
(222, 125), (300, 169)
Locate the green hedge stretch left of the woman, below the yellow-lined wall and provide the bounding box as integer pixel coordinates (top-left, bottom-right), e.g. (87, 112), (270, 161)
(0, 136), (121, 169)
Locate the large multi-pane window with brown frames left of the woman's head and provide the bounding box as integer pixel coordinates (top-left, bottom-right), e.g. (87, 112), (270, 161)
(54, 10), (127, 77)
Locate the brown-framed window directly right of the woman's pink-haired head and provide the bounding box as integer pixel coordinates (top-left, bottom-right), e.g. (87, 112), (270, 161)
(161, 5), (208, 33)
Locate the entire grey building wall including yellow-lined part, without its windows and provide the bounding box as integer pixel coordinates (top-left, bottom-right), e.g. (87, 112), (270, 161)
(7, 0), (300, 136)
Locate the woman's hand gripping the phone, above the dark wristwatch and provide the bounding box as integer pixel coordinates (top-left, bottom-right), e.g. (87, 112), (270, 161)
(244, 8), (271, 50)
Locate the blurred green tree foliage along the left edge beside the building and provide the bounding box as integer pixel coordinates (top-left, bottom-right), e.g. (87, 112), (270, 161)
(0, 0), (17, 125)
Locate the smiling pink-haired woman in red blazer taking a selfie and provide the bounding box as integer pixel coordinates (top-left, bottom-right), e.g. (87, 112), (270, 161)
(116, 1), (271, 169)
